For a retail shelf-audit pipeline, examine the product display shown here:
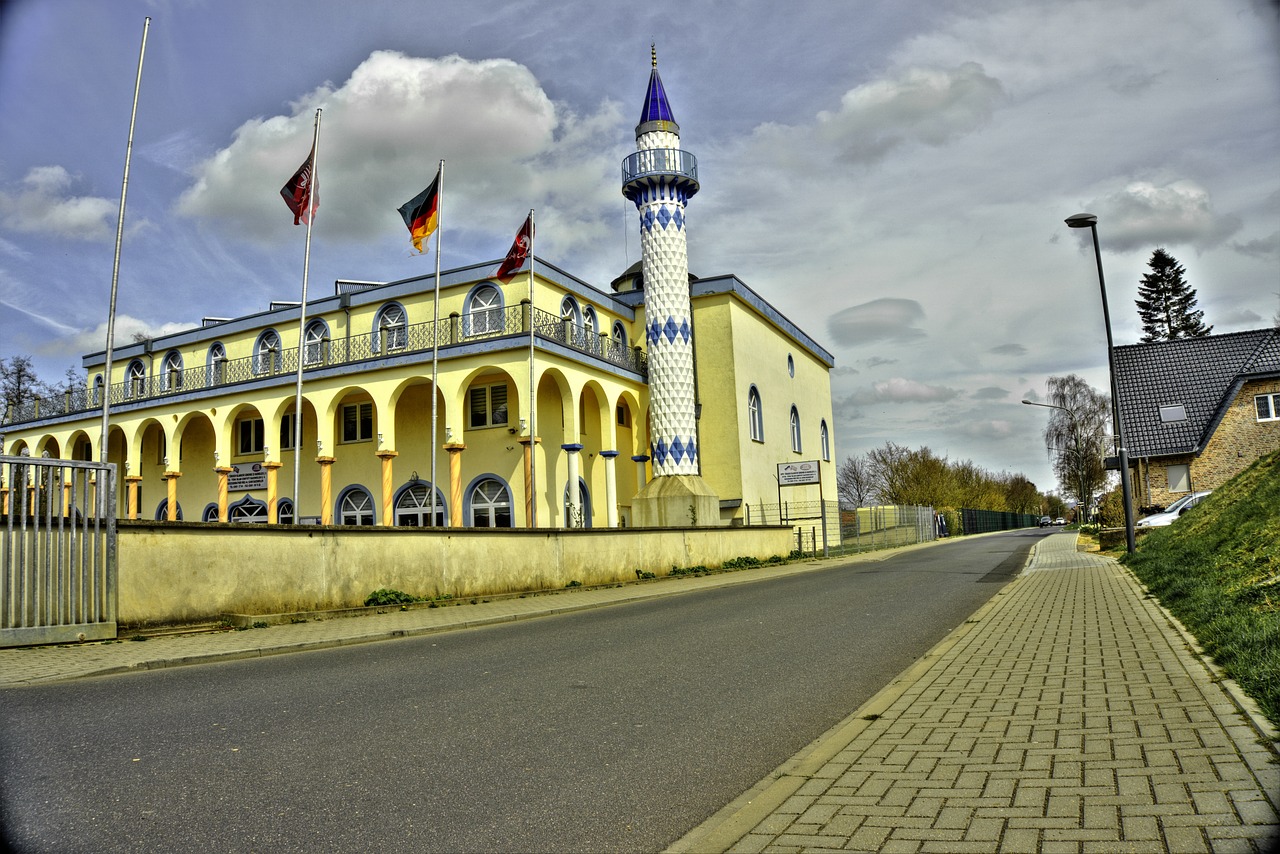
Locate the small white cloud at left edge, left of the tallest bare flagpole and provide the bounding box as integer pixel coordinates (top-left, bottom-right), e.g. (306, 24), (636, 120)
(0, 166), (119, 241)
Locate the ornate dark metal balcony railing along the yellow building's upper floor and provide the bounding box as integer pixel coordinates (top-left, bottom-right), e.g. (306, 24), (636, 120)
(0, 303), (649, 424)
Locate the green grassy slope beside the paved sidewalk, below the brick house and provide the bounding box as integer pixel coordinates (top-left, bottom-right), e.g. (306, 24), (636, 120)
(1123, 452), (1280, 727)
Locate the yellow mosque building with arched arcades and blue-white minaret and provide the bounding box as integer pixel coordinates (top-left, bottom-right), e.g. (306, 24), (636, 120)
(0, 59), (836, 529)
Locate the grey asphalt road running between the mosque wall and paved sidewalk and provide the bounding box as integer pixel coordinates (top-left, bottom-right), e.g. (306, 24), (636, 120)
(0, 530), (1043, 854)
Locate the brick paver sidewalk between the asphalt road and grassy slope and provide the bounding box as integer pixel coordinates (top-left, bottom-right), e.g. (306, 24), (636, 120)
(671, 534), (1280, 853)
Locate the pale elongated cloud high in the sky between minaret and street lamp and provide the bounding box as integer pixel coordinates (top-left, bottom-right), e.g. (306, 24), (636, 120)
(818, 63), (1004, 163)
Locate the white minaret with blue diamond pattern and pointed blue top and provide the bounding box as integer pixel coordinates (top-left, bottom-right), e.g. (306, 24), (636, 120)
(622, 50), (719, 528)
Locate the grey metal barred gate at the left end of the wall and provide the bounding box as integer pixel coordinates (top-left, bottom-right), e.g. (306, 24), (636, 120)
(0, 456), (118, 647)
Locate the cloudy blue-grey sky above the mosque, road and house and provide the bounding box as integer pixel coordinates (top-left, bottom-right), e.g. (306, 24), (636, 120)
(0, 0), (1280, 490)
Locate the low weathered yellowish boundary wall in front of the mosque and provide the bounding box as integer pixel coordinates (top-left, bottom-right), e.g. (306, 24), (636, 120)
(116, 520), (794, 626)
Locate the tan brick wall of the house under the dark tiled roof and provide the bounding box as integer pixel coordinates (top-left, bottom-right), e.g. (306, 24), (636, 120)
(1134, 379), (1280, 506)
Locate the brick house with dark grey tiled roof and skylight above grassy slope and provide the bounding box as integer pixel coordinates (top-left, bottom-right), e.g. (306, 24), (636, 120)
(1115, 329), (1280, 508)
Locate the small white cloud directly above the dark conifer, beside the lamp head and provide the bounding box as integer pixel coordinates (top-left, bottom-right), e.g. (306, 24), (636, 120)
(1080, 181), (1242, 252)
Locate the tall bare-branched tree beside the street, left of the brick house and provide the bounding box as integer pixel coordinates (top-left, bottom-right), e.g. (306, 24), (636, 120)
(1044, 374), (1111, 521)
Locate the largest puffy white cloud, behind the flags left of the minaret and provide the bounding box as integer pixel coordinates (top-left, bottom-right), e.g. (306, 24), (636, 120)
(174, 51), (626, 254)
